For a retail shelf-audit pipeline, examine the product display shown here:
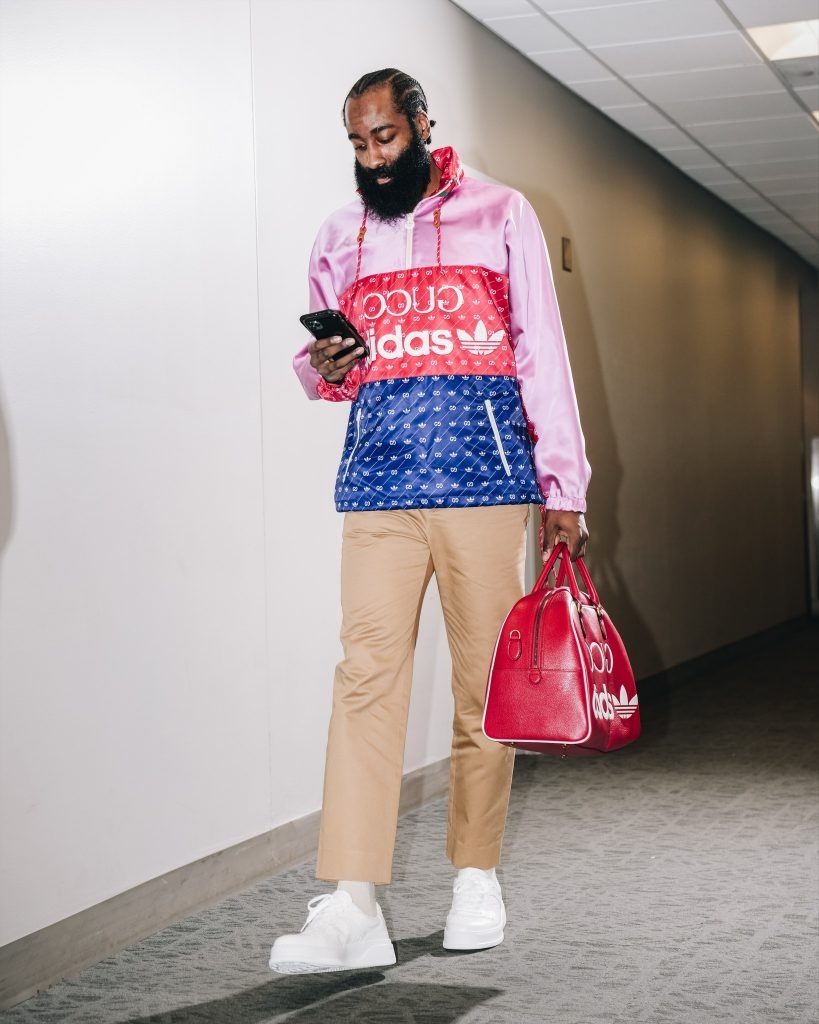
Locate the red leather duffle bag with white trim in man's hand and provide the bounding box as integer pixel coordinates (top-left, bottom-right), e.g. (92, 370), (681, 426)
(483, 544), (640, 757)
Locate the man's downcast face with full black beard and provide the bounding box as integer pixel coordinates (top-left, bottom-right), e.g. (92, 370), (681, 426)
(344, 85), (430, 221)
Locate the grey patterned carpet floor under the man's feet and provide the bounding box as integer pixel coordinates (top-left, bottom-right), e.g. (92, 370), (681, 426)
(0, 624), (819, 1024)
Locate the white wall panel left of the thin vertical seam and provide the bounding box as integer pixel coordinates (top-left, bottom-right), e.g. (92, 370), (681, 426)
(0, 0), (272, 942)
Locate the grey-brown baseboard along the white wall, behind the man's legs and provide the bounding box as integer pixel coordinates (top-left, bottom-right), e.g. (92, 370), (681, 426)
(0, 758), (449, 1010)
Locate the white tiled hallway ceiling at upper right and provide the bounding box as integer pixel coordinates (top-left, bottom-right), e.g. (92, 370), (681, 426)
(452, 0), (819, 267)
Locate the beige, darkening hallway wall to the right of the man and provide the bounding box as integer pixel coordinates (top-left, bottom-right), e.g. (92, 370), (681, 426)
(427, 9), (815, 674)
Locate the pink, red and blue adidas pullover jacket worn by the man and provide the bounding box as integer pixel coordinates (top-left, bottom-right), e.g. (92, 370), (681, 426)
(293, 148), (591, 512)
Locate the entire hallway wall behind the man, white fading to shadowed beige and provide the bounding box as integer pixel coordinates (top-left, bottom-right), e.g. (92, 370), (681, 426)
(0, 0), (805, 943)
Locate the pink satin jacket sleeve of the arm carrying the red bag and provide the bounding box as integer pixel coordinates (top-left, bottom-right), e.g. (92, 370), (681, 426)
(507, 197), (592, 512)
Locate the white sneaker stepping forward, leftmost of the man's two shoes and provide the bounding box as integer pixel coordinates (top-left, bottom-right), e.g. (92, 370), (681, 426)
(270, 890), (395, 974)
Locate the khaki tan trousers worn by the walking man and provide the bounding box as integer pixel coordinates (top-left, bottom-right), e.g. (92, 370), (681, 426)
(316, 505), (528, 884)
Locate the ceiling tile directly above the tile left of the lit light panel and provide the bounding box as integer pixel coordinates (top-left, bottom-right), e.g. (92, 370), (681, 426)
(552, 0), (736, 46)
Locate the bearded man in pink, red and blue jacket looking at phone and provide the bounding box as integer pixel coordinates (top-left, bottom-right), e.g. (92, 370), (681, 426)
(270, 69), (590, 973)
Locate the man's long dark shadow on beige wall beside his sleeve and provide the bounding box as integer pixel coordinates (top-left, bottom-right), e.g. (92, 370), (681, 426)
(526, 189), (670, 736)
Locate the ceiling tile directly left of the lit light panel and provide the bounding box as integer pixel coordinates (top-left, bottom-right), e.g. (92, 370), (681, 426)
(591, 32), (761, 78)
